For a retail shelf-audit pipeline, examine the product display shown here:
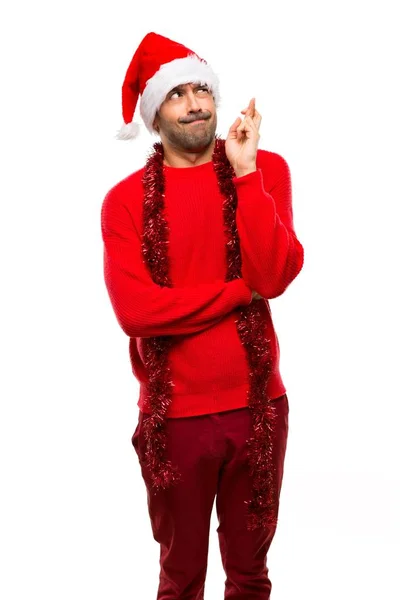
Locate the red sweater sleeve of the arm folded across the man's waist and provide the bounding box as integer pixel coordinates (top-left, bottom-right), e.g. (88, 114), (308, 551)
(101, 189), (252, 338)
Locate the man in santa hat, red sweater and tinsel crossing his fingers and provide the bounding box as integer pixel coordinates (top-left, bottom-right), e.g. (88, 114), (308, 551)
(101, 32), (304, 600)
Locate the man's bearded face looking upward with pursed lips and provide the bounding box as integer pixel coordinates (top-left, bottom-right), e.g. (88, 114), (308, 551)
(154, 83), (217, 152)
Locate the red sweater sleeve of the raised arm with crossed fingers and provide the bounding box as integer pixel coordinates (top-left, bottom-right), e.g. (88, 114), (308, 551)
(233, 154), (304, 298)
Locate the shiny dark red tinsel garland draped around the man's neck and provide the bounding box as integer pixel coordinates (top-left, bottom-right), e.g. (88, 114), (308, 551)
(138, 135), (277, 530)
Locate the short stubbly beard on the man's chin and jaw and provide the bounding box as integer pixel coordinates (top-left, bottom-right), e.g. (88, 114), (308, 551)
(160, 117), (217, 152)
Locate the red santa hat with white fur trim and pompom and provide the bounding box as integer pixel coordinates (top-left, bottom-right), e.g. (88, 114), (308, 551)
(116, 32), (220, 140)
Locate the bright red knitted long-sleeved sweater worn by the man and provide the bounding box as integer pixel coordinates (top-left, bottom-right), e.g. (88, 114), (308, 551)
(101, 149), (304, 418)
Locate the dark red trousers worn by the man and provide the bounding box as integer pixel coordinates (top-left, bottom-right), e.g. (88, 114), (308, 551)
(132, 394), (289, 600)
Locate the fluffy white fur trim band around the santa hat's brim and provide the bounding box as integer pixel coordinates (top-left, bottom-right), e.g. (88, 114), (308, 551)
(140, 54), (220, 133)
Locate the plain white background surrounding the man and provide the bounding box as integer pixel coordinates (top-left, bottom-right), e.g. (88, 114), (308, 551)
(0, 0), (414, 600)
